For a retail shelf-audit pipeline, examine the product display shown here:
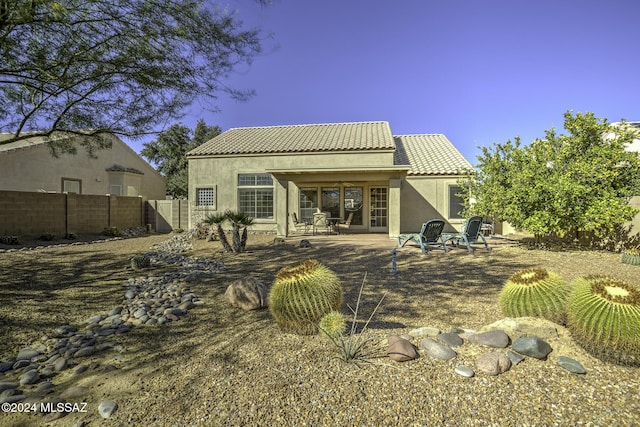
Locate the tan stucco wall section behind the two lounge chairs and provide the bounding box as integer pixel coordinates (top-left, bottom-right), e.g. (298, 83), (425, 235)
(400, 176), (465, 233)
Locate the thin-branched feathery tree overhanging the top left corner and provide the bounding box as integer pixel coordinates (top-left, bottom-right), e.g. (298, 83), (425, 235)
(0, 0), (268, 154)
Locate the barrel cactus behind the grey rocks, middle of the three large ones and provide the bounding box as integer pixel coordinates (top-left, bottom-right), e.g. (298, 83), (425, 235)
(500, 268), (571, 324)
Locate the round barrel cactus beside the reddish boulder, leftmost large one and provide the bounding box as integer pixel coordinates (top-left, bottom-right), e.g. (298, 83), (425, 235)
(269, 260), (343, 335)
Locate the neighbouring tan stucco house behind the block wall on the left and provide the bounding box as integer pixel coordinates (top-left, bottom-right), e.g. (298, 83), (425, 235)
(0, 134), (166, 200)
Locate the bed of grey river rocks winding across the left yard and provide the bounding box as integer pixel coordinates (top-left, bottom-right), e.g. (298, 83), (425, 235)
(0, 235), (224, 421)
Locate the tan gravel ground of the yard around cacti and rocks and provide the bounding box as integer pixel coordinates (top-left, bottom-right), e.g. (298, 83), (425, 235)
(0, 235), (640, 426)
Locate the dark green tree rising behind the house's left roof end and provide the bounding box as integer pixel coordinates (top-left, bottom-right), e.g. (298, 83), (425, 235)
(140, 119), (222, 197)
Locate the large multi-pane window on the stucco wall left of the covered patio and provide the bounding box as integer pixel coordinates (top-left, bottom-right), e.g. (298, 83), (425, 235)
(238, 173), (273, 218)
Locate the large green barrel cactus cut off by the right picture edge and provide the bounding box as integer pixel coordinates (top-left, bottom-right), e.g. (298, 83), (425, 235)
(567, 276), (640, 366)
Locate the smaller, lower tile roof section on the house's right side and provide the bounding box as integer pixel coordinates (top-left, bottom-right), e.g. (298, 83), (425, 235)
(394, 134), (472, 175)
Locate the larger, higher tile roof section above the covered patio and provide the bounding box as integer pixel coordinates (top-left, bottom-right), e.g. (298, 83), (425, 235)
(187, 122), (395, 156)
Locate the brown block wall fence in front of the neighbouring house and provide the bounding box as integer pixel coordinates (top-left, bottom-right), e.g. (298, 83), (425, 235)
(0, 191), (146, 236)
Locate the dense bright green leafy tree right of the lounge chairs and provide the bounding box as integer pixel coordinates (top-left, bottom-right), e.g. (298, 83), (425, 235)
(463, 112), (640, 236)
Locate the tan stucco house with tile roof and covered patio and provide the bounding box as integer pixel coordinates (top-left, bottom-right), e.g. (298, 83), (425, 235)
(187, 122), (472, 237)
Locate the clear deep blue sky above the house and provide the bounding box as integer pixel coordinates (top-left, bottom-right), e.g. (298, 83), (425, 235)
(132, 0), (640, 164)
